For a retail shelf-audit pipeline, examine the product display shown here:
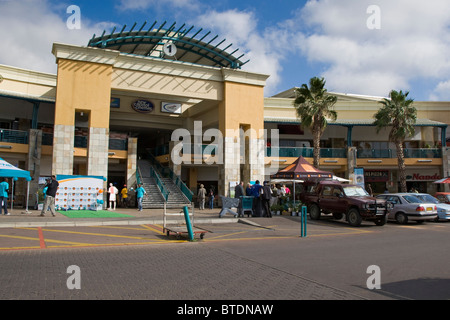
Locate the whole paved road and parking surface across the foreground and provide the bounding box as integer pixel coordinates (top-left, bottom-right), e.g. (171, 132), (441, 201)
(0, 217), (450, 301)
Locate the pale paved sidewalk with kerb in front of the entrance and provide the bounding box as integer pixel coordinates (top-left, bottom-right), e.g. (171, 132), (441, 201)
(0, 208), (238, 228)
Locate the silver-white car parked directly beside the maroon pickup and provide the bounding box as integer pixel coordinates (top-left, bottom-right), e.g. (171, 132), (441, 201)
(377, 193), (438, 224)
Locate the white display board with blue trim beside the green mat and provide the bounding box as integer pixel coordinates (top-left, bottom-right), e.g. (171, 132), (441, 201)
(55, 175), (104, 210)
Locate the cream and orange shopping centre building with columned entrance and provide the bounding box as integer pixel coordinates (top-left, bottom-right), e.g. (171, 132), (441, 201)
(0, 25), (450, 208)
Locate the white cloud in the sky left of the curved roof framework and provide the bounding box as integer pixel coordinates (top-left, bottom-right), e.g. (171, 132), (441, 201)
(0, 0), (114, 73)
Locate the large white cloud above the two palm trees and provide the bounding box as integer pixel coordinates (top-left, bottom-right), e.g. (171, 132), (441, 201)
(296, 0), (450, 96)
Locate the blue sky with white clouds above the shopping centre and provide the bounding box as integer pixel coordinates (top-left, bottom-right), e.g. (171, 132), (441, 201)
(0, 0), (450, 101)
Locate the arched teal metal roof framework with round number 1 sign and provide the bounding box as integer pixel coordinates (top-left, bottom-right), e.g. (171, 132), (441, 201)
(88, 21), (250, 69)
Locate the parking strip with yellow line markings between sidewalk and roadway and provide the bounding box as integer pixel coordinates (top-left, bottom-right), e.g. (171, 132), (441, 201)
(0, 216), (450, 250)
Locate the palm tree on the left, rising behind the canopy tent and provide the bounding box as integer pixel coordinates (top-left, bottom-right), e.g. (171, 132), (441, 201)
(294, 77), (337, 168)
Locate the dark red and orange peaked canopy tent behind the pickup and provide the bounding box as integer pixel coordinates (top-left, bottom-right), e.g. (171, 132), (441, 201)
(270, 156), (333, 182)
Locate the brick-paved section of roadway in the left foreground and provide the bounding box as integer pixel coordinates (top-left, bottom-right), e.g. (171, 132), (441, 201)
(0, 243), (361, 300)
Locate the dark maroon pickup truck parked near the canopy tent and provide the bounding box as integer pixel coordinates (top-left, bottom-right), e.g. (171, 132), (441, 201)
(301, 180), (389, 227)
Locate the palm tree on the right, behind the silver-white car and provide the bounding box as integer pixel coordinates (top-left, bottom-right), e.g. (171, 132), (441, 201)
(374, 90), (417, 192)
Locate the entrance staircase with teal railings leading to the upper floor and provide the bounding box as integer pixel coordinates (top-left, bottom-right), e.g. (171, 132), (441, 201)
(138, 159), (191, 209)
